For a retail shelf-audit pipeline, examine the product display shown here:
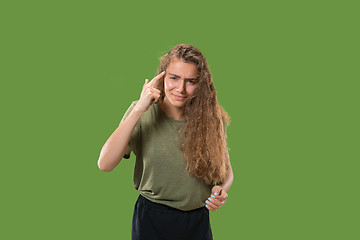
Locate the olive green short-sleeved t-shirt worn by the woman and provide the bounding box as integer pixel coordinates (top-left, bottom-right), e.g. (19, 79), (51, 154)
(120, 101), (213, 211)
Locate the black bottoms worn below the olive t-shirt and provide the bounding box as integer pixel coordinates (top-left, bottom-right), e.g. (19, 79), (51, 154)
(132, 194), (213, 240)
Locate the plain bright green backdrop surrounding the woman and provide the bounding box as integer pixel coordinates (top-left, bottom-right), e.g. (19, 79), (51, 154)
(0, 0), (360, 240)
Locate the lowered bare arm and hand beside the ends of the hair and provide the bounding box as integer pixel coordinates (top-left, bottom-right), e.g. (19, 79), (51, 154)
(205, 153), (234, 212)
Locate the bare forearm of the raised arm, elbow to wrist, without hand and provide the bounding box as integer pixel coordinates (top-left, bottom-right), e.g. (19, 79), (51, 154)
(98, 107), (143, 172)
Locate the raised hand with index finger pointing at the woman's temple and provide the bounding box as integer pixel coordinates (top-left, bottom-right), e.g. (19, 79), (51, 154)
(136, 71), (165, 112)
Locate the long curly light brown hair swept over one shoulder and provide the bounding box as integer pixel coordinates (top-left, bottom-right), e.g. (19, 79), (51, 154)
(156, 44), (230, 185)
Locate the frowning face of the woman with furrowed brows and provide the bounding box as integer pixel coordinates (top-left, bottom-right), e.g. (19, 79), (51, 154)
(164, 58), (198, 108)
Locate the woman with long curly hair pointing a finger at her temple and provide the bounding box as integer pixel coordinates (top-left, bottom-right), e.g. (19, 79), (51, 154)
(98, 44), (233, 240)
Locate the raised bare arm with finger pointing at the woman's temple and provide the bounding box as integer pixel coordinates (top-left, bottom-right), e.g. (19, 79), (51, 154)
(98, 71), (165, 172)
